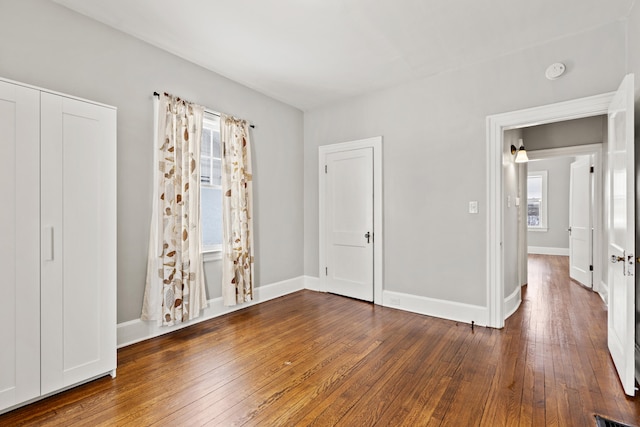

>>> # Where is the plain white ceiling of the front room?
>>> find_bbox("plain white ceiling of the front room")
[53,0,635,110]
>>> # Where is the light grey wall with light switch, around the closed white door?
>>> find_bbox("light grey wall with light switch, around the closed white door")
[304,22,626,306]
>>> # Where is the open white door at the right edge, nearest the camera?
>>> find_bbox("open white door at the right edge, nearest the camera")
[608,74,635,396]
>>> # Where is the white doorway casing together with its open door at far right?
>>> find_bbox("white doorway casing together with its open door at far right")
[487,74,640,396]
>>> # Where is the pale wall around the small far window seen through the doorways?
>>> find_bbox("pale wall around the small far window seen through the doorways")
[527,157,574,254]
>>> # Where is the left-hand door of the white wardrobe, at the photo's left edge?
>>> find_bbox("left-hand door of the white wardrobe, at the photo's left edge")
[0,82,40,411]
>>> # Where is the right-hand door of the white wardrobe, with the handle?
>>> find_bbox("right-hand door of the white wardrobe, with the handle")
[41,92,116,394]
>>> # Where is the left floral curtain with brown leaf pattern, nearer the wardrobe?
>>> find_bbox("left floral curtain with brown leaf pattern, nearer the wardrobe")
[141,93,207,326]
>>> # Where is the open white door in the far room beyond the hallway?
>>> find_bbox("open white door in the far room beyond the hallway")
[569,156,593,288]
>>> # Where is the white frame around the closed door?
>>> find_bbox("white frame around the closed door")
[318,136,384,305]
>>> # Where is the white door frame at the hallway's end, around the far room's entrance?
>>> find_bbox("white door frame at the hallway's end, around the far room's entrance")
[527,143,607,292]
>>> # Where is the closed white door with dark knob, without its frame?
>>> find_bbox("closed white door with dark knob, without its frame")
[320,147,374,301]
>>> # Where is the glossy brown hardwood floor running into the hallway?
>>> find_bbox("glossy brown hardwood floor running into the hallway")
[0,256,640,426]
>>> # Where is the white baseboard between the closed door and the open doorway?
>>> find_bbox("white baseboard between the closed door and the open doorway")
[382,291,489,326]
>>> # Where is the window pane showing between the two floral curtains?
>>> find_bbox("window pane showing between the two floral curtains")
[200,113,222,253]
